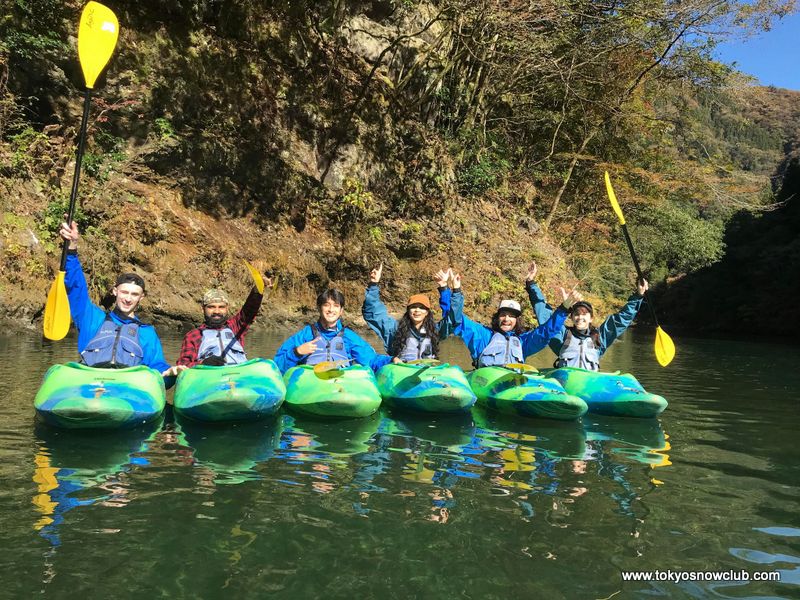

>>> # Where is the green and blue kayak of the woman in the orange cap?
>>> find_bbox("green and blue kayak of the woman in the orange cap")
[377,363,475,413]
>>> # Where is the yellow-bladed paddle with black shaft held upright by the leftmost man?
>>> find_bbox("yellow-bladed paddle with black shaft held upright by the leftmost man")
[43,2,119,340]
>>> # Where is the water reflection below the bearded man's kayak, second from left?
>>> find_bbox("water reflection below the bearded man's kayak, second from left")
[178,417,283,483]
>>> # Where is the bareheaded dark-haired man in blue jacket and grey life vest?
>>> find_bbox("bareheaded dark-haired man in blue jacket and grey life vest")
[275,289,391,373]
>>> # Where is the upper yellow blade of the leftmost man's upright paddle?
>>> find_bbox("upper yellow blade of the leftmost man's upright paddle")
[78,2,119,89]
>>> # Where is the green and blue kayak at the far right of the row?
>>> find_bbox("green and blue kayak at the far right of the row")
[543,367,667,418]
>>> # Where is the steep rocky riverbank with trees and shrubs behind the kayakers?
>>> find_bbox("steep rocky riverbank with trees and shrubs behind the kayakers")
[0,0,800,338]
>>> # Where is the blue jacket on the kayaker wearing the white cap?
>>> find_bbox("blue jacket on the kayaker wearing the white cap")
[450,290,568,361]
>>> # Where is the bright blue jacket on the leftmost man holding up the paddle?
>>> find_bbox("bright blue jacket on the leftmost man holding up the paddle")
[64,253,170,373]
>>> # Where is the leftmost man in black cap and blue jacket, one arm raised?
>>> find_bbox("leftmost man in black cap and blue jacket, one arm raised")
[59,221,186,377]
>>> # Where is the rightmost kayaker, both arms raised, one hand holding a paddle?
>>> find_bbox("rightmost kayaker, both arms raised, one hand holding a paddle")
[525,262,650,371]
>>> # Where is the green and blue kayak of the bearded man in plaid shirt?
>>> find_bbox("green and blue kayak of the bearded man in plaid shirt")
[174,358,286,421]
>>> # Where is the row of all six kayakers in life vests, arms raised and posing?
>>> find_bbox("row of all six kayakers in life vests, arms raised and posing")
[60,222,648,379]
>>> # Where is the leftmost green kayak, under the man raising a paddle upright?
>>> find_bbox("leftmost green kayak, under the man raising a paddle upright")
[33,363,166,429]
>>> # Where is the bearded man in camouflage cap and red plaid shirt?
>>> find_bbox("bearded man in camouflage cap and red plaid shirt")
[178,278,271,367]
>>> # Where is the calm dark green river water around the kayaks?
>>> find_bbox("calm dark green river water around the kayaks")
[0,332,800,600]
